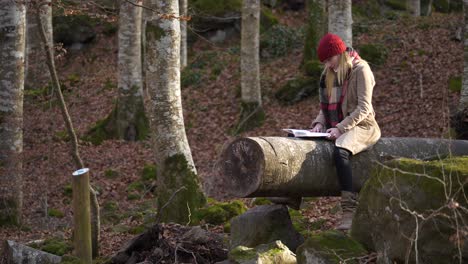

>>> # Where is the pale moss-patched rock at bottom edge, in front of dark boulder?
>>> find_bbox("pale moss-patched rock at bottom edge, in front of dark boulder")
[227,240,296,264]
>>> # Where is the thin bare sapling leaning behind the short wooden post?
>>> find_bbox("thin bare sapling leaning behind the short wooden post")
[36,3,101,257]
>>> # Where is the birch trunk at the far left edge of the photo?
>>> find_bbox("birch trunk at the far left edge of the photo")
[0,0,26,225]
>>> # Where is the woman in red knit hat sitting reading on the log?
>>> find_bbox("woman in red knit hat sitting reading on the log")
[310,33,381,230]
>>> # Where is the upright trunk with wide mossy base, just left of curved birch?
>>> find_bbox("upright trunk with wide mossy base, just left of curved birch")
[113,0,148,141]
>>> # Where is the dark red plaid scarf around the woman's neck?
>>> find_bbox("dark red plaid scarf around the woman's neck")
[319,47,360,128]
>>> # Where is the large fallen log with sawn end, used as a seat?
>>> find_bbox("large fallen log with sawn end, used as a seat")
[204,137,468,199]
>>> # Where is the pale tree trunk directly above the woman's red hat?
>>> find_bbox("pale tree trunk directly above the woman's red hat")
[328,0,353,47]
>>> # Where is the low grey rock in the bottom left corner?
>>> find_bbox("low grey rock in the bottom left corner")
[0,240,62,264]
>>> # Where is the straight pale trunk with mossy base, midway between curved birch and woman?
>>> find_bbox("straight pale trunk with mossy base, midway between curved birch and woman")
[235,0,264,134]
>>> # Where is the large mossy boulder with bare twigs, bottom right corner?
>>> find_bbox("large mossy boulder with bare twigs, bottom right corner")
[351,156,468,263]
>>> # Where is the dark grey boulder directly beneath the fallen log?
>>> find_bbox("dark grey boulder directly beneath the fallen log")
[230,205,304,251]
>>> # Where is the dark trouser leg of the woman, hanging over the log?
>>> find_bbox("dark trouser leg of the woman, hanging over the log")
[333,146,353,192]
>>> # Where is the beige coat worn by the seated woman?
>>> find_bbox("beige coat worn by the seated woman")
[311,60,381,155]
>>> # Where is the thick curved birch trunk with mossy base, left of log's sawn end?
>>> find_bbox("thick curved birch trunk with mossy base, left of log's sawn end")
[146,0,206,224]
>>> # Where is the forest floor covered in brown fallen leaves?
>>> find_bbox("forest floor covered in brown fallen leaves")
[0,3,463,262]
